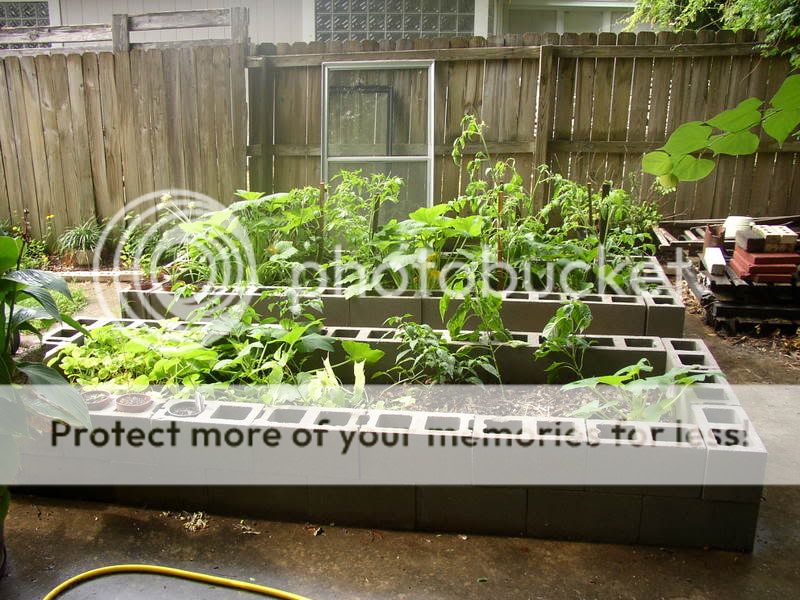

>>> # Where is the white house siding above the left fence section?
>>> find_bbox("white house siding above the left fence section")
[50,0,304,43]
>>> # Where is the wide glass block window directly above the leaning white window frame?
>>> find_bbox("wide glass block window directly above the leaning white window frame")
[314,0,475,42]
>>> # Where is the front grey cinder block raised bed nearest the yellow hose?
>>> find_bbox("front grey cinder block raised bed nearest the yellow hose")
[23,323,766,551]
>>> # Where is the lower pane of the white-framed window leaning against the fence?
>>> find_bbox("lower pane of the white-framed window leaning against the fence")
[328,161,428,224]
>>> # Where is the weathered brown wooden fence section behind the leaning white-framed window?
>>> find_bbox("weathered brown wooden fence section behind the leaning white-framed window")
[248,31,800,218]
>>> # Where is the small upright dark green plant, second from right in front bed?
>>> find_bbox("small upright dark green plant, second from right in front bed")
[534,300,592,382]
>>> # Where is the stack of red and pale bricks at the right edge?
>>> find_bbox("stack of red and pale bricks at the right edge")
[731,225,800,283]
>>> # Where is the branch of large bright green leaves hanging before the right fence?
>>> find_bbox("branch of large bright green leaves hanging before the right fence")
[642,75,800,190]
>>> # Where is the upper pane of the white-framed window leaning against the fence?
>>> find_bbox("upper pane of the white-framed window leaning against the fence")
[328,68,428,156]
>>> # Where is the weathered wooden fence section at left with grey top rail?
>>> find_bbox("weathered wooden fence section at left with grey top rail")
[0,9,247,235]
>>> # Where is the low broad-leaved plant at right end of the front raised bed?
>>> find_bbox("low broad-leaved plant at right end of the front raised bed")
[562,358,708,422]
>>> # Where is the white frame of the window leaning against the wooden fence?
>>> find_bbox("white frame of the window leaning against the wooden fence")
[320,60,435,207]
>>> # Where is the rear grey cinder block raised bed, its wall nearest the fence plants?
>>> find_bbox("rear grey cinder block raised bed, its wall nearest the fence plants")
[120,259,684,337]
